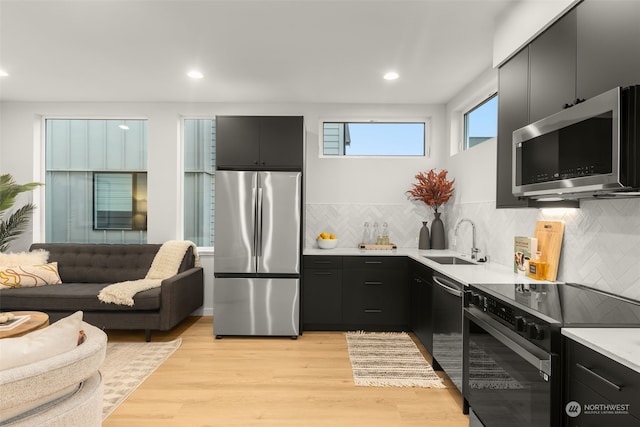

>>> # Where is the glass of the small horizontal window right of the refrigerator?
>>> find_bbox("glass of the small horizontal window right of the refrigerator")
[322,122,426,156]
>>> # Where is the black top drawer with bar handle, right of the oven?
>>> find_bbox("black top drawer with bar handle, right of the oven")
[567,340,640,418]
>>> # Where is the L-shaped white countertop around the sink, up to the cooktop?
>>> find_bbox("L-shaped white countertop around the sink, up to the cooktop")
[303,248,548,285]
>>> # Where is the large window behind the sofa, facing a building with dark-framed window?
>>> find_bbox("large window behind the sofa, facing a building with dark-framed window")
[44,119,147,243]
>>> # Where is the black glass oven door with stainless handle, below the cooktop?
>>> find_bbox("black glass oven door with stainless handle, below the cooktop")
[463,307,560,427]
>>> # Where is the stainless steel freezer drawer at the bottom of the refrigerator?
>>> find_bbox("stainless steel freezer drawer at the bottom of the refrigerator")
[213,278,300,337]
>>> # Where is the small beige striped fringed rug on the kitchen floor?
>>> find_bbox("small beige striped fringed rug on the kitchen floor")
[345,332,445,388]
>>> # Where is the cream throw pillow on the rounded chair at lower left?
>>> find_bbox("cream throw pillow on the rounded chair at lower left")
[0,311,82,371]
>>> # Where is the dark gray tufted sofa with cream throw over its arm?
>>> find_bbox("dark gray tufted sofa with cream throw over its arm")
[0,243,204,341]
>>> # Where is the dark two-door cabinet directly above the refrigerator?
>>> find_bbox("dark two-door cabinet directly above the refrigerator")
[216,116,304,170]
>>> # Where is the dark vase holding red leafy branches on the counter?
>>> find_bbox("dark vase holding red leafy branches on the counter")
[407,169,455,249]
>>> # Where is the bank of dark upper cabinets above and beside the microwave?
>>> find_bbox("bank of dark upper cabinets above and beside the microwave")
[496,0,640,208]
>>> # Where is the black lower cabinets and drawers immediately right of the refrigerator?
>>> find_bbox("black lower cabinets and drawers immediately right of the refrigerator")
[302,255,409,331]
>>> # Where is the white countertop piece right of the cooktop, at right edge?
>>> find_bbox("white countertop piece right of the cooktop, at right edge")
[562,328,640,373]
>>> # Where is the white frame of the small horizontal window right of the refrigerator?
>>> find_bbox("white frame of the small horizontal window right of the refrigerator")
[318,117,432,159]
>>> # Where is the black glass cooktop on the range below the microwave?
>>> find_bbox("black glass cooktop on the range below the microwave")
[471,283,640,327]
